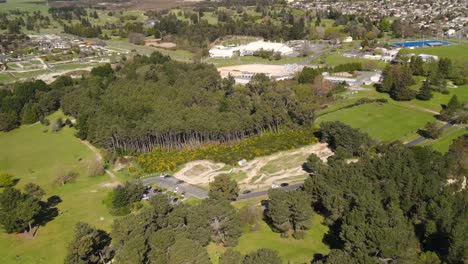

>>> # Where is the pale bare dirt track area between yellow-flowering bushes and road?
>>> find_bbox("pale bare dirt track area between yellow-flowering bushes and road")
[174,143,333,190]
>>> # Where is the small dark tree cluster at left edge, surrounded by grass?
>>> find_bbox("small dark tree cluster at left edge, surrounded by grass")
[0,182,61,236]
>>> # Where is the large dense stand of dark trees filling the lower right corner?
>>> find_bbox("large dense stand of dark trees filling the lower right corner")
[304,123,468,263]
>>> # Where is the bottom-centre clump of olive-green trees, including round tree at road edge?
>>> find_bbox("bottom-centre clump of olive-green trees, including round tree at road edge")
[65,175,286,264]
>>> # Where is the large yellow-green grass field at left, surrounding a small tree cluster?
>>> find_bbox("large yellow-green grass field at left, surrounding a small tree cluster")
[0,111,112,264]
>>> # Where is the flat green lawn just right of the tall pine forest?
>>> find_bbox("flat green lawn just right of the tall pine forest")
[317,103,435,141]
